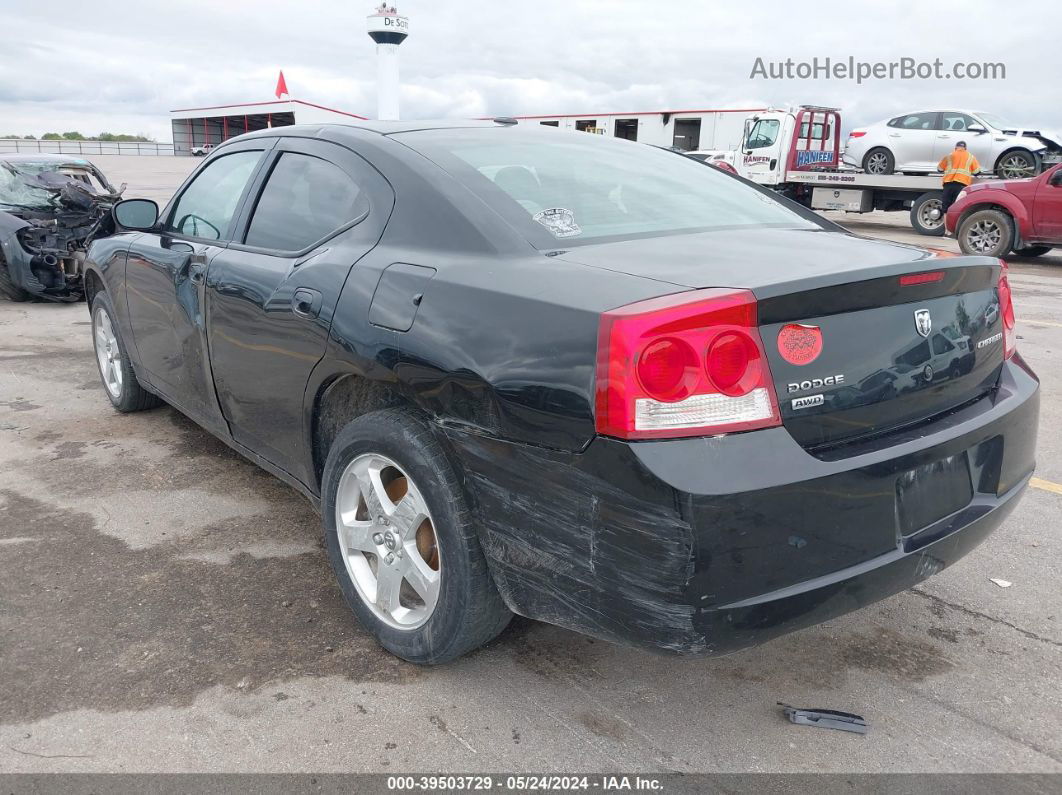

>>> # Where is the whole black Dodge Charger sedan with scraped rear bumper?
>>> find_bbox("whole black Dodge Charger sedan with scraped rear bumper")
[86,120,1039,662]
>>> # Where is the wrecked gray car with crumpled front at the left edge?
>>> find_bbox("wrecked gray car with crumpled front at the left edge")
[0,154,125,301]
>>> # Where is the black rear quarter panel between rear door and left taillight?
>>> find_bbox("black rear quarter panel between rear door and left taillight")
[315,249,681,451]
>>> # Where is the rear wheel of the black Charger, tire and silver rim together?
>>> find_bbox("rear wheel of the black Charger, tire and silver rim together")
[321,409,512,664]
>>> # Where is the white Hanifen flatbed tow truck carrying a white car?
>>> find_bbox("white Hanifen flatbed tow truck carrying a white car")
[695,105,993,236]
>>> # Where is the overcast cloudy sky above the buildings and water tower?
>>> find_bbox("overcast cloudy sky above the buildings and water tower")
[0,0,1062,140]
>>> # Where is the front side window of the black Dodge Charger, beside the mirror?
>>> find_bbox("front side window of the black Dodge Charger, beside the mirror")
[167,151,261,240]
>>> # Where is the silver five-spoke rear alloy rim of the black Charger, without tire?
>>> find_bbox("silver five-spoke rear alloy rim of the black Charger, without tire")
[336,453,442,629]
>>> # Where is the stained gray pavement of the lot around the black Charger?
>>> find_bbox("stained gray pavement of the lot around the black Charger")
[0,157,1062,773]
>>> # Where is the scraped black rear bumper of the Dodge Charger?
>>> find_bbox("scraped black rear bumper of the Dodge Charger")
[448,358,1039,654]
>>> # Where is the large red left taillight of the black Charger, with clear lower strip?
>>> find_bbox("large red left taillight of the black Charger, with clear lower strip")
[596,290,781,438]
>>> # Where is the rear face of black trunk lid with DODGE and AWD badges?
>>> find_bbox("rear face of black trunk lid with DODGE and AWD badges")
[759,258,1004,451]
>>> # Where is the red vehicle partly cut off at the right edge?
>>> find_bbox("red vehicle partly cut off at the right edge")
[945,165,1062,257]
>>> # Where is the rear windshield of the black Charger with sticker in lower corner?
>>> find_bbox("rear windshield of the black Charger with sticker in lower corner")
[396,128,820,247]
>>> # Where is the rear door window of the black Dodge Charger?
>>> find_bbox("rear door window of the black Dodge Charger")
[244,152,367,252]
